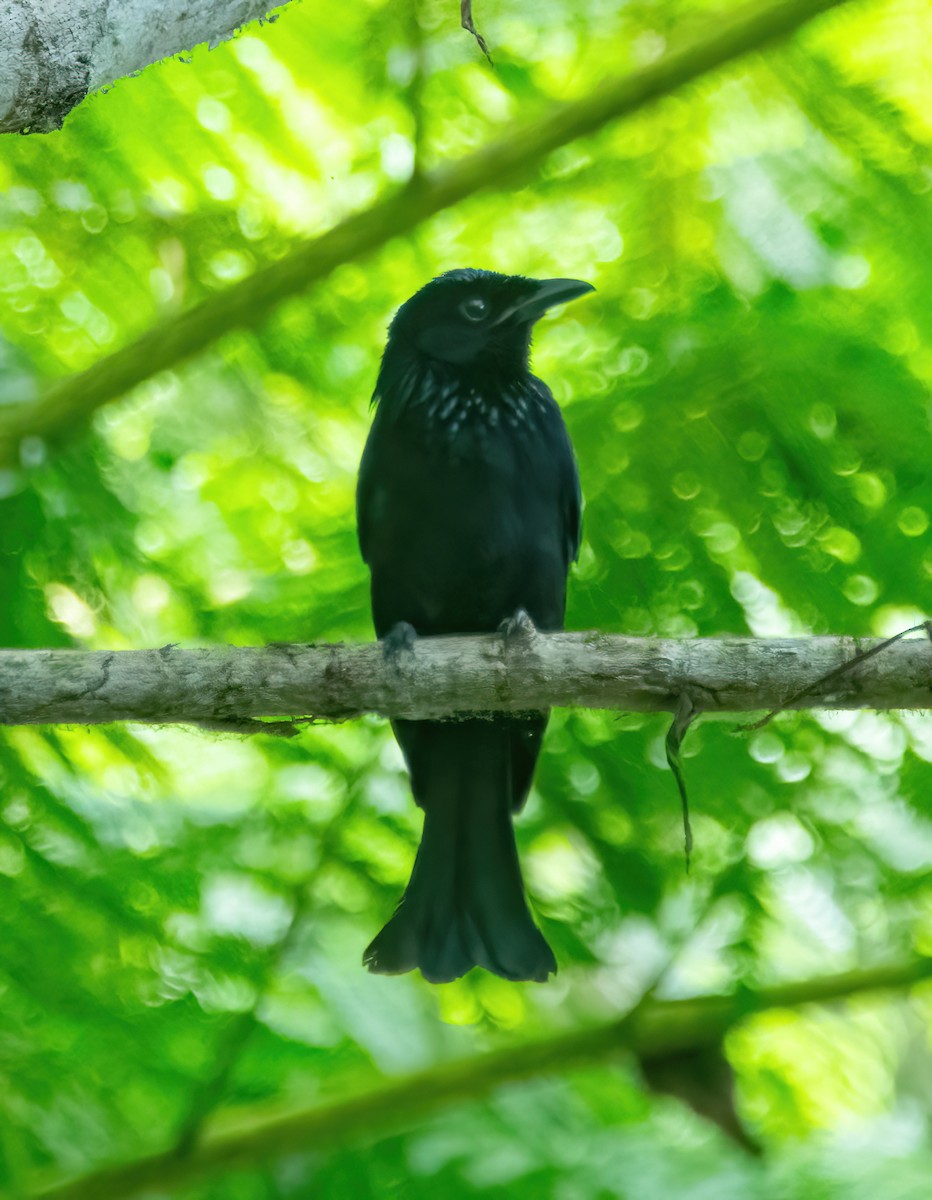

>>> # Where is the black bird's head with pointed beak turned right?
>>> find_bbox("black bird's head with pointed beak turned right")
[385,268,595,376]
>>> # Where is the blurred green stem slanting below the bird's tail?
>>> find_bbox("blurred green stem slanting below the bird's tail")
[32,959,932,1200]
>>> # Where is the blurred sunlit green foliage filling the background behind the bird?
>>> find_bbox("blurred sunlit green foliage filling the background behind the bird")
[0,0,932,1198]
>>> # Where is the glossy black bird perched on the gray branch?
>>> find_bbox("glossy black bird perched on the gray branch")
[356,269,594,983]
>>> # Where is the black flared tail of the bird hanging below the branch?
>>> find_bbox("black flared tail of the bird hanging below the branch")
[362,734,557,983]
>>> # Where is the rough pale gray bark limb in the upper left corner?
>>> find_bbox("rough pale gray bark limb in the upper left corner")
[0,0,287,133]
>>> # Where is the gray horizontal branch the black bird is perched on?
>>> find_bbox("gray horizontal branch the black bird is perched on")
[0,632,932,732]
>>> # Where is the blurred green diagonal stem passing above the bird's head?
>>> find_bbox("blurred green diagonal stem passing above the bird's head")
[0,0,849,466]
